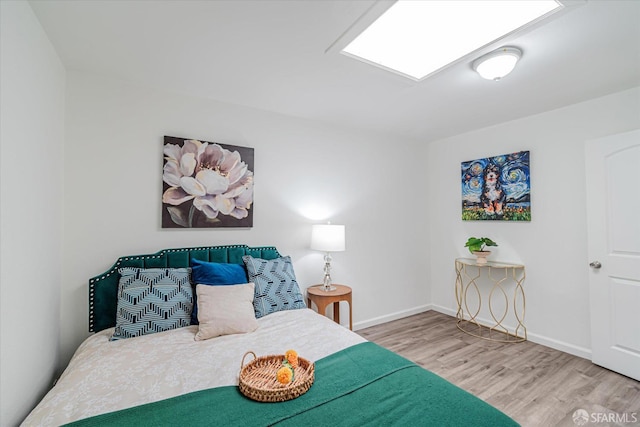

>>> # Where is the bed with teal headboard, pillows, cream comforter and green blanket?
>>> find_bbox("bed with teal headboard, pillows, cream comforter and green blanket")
[22,245,517,427]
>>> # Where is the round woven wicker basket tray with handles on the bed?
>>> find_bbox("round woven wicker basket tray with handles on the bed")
[238,351,315,402]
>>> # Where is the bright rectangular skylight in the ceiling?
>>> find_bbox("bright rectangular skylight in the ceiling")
[342,0,562,80]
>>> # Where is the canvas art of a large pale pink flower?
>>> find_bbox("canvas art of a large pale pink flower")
[162,136,254,228]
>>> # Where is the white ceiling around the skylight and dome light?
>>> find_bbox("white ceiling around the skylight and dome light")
[30,0,640,141]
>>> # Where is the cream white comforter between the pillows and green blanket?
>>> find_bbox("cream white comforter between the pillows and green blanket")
[22,309,365,426]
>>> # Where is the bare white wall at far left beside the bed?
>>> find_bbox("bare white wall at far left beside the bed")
[0,1,65,426]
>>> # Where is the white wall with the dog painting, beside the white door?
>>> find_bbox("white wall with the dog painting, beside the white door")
[424,88,640,357]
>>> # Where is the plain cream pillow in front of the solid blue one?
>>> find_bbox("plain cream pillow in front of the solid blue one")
[195,283,258,341]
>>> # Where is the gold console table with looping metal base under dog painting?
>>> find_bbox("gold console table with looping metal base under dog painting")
[455,258,527,342]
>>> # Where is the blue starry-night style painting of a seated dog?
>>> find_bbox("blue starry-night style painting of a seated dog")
[461,151,531,221]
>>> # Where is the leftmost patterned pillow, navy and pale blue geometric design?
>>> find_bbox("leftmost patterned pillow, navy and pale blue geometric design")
[111,267,193,341]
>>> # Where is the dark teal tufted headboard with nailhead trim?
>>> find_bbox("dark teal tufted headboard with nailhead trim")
[89,245,280,332]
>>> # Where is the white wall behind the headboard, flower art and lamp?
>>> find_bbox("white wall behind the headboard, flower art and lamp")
[61,72,428,366]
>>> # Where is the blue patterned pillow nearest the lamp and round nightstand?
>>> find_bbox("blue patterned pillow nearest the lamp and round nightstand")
[242,255,307,318]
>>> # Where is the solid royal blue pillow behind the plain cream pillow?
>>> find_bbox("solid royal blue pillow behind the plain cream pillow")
[191,258,247,325]
